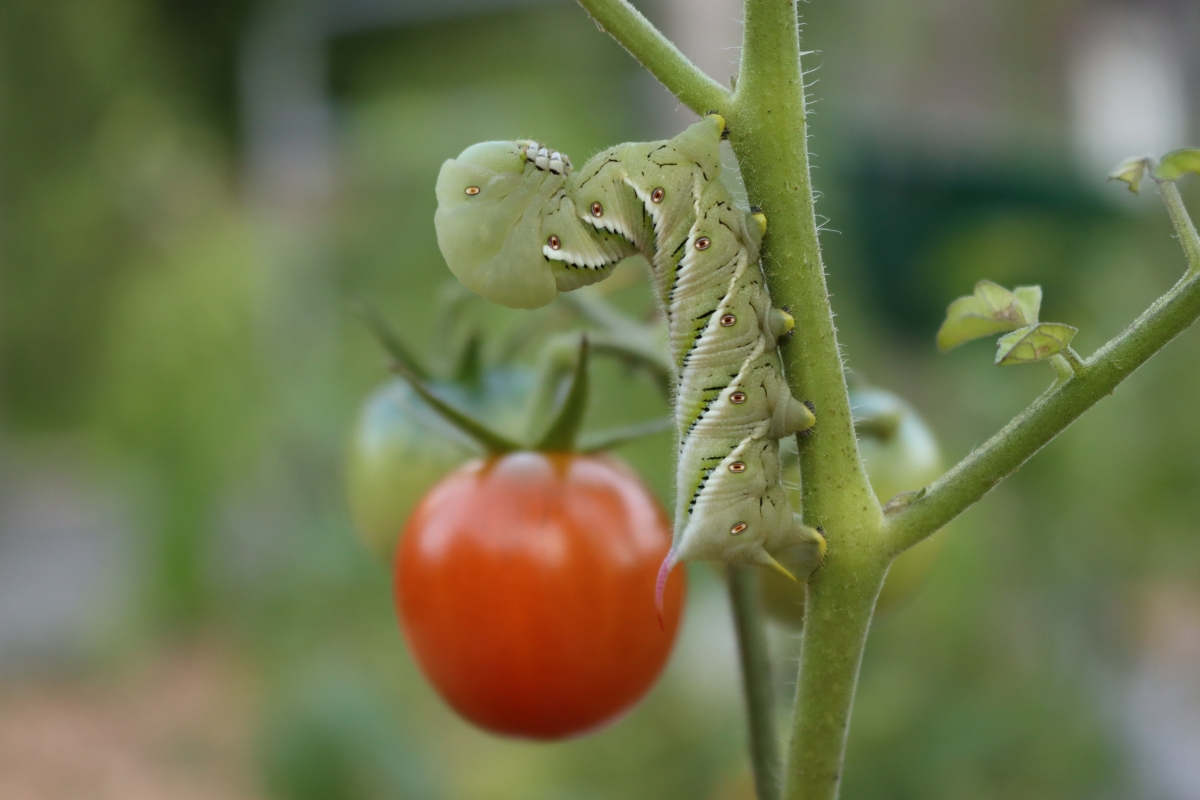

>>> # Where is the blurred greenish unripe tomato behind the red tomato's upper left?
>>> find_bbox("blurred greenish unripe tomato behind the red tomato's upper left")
[346,369,532,564]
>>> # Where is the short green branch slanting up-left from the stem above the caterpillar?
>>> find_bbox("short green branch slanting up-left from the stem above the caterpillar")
[578,0,730,115]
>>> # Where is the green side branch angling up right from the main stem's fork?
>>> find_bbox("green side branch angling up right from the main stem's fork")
[887,271,1200,553]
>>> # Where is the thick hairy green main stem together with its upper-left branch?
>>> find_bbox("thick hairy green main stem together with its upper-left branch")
[580,0,887,800]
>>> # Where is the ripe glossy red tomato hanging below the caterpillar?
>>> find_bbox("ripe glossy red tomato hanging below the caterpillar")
[396,452,685,739]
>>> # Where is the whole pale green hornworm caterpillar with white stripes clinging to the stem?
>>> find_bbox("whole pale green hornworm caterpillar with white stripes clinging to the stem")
[434,114,824,606]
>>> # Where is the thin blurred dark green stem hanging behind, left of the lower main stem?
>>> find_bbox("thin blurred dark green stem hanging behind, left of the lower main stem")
[728,566,782,800]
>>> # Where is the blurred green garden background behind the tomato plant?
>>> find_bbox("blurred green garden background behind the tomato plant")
[0,0,1200,800]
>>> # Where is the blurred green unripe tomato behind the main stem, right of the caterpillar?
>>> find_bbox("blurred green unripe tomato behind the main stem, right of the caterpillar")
[761,389,942,625]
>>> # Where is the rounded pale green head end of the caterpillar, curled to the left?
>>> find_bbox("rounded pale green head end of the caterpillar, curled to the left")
[433,140,632,308]
